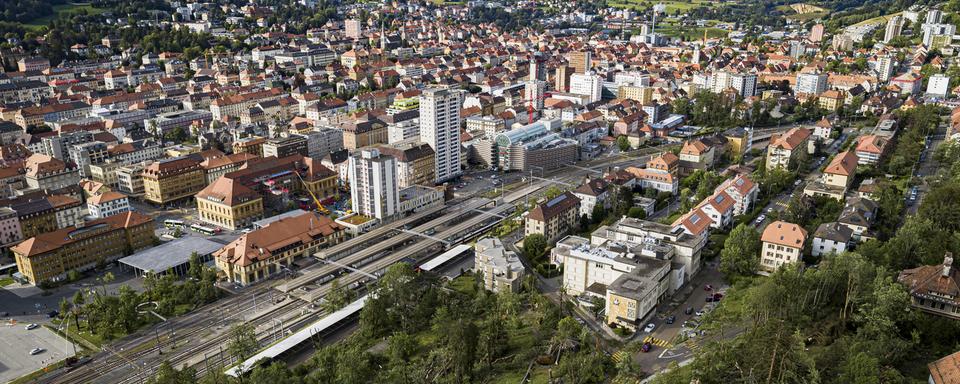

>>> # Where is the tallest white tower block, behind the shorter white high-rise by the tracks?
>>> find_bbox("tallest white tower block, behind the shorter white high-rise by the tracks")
[420,88,463,183]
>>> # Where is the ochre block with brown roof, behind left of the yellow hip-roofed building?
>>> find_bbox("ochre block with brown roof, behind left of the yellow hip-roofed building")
[143,155,206,205]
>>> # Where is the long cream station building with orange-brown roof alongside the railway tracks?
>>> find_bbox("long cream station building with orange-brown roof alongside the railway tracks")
[213,212,345,285]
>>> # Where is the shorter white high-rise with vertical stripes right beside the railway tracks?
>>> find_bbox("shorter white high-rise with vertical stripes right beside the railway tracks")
[348,149,400,220]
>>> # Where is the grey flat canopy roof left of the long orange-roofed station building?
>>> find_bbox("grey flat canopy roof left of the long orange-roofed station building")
[119,236,223,272]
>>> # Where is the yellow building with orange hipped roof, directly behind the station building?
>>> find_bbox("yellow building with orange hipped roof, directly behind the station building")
[196,176,263,230]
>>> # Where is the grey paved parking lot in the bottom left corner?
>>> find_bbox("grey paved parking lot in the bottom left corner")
[0,319,73,383]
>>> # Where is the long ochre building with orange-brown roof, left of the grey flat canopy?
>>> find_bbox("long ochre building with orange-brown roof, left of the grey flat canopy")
[10,212,154,285]
